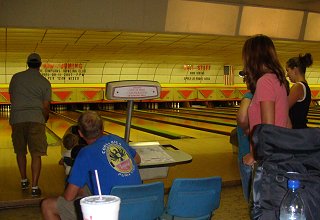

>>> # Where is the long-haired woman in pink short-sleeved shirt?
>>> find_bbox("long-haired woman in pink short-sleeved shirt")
[242,35,290,165]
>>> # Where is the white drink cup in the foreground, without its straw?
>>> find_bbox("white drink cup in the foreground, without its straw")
[80,195,121,220]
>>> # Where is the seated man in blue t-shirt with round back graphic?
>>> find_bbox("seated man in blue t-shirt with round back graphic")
[41,111,142,219]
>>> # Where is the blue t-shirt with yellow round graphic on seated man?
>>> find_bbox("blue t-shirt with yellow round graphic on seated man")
[68,135,142,195]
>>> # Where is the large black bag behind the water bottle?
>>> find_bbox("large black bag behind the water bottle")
[251,124,320,220]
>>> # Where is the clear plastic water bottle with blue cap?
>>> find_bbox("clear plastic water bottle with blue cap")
[280,179,306,220]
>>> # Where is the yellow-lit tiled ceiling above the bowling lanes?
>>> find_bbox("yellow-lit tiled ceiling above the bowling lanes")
[0,0,320,66]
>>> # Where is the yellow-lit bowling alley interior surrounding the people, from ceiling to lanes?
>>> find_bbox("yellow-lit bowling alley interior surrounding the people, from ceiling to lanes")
[0,0,320,220]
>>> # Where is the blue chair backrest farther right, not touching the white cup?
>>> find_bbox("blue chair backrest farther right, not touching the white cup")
[165,177,222,219]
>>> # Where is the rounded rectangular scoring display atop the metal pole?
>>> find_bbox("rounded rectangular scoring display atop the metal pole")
[106,80,161,100]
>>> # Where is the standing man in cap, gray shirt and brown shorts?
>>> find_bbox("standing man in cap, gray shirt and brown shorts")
[9,53,51,196]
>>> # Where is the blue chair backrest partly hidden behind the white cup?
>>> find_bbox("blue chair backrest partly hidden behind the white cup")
[110,182,164,220]
